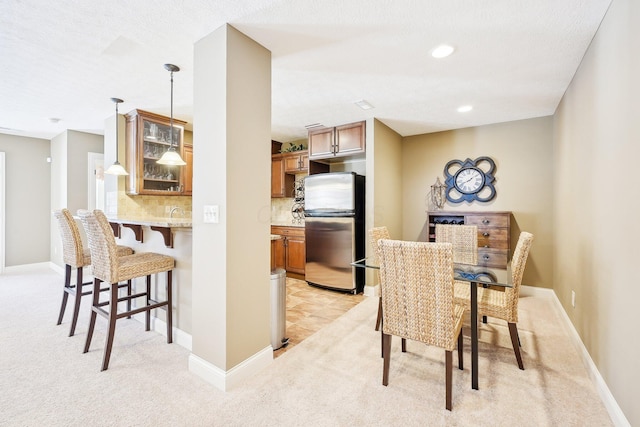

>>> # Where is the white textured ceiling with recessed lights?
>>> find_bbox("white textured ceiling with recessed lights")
[0,0,611,142]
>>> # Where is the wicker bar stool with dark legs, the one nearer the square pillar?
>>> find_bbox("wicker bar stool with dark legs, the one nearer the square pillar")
[78,210,175,371]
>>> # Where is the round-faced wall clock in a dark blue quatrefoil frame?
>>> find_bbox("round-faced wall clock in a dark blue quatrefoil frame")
[444,156,496,203]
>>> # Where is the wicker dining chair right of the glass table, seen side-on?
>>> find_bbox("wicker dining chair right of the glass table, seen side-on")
[454,231,533,370]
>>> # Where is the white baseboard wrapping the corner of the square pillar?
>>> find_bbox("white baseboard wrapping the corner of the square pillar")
[189,345,273,392]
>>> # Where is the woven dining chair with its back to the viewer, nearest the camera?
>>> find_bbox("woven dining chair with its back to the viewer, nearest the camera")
[378,239,464,410]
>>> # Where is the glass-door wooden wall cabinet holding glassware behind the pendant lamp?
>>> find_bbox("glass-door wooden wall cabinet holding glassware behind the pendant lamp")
[126,110,187,196]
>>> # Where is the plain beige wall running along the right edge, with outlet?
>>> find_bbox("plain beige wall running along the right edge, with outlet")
[554,0,640,425]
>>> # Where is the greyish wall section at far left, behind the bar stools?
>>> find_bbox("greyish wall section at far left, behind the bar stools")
[0,133,51,267]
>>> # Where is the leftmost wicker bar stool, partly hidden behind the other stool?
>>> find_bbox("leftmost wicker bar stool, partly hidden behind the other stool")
[53,208,133,337]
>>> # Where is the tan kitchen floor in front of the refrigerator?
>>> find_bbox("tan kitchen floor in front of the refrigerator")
[273,277,364,357]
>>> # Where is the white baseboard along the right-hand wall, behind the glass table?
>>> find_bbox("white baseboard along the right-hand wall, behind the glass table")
[520,286,631,427]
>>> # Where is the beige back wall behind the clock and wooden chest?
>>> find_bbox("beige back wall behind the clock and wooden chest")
[402,117,554,288]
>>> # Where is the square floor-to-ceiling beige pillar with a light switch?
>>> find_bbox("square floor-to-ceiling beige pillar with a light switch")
[192,25,271,372]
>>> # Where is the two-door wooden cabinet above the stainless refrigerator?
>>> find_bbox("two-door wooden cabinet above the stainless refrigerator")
[309,121,366,160]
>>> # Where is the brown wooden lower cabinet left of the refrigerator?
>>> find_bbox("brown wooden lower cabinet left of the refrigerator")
[271,225,306,274]
